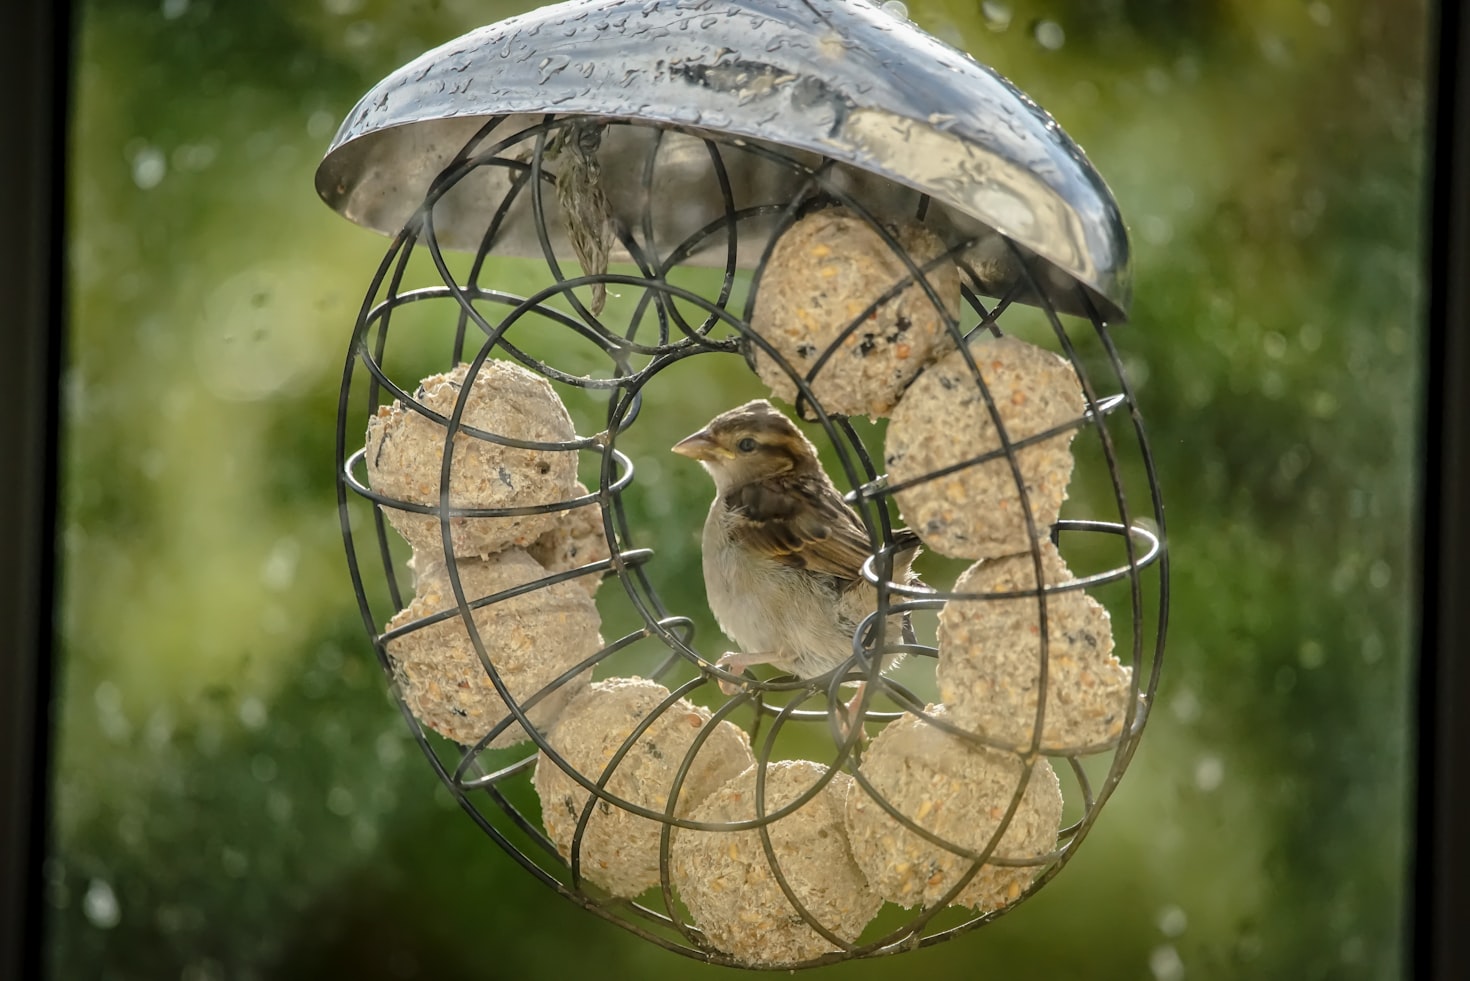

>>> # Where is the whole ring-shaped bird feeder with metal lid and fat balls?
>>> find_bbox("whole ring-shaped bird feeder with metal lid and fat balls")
[318,0,1169,969]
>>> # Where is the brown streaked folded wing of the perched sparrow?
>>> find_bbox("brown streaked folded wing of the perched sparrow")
[725,474,870,579]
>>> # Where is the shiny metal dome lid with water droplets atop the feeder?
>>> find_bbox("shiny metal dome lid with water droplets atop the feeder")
[316,0,1130,321]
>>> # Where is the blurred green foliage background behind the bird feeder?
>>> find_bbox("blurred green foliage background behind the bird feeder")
[47,0,1430,981]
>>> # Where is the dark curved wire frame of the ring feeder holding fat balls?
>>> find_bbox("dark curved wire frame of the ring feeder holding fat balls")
[337,115,1169,969]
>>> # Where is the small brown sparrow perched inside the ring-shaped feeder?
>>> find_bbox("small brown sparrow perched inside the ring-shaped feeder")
[673,399,919,705]
